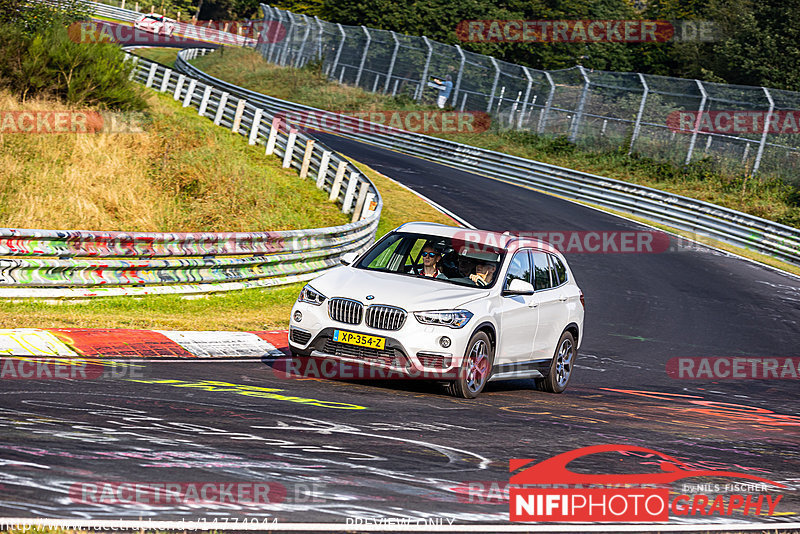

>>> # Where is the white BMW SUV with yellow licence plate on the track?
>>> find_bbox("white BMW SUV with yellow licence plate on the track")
[289,222,584,398]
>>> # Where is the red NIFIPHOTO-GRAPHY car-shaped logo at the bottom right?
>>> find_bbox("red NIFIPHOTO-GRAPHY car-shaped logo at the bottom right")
[509,444,786,523]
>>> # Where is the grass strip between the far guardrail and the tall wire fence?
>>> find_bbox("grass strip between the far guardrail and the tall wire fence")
[193,48,800,227]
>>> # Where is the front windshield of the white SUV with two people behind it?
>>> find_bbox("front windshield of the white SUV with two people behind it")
[355,232,504,287]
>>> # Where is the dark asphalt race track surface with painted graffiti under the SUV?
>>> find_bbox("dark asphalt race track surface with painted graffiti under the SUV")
[0,52,800,529]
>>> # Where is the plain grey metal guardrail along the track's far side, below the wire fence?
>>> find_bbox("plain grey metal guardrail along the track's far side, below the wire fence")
[175,49,800,265]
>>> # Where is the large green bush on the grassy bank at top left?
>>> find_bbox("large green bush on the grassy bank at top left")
[0,22,146,111]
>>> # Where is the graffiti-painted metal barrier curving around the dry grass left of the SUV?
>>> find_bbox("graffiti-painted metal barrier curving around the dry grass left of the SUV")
[0,50,383,298]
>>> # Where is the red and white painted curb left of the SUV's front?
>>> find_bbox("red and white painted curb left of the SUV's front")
[0,328,288,358]
